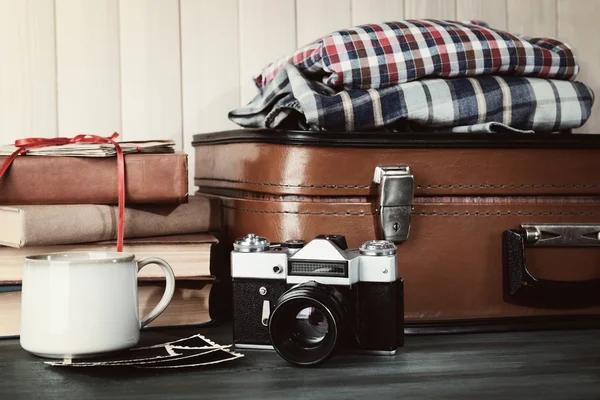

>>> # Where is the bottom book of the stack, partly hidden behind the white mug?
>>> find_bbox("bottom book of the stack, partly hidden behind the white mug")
[0,280,213,338]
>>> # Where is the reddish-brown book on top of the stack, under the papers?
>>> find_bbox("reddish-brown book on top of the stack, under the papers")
[0,153,188,204]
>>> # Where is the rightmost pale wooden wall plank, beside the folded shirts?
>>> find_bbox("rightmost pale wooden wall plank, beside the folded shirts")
[558,0,600,134]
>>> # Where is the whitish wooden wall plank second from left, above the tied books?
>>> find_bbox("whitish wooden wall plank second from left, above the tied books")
[55,0,121,136]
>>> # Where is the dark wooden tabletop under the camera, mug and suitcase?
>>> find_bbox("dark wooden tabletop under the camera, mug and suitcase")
[0,326,600,400]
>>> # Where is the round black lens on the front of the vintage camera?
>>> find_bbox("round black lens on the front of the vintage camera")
[269,281,344,366]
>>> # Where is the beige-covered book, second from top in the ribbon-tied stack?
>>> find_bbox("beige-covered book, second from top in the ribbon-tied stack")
[0,196,221,247]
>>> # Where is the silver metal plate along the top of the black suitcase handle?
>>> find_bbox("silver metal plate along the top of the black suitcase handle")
[521,224,600,247]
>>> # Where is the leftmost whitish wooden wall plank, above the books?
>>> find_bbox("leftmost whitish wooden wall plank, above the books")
[0,0,57,144]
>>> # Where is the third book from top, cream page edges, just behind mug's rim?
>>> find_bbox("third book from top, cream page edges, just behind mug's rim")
[0,233,217,285]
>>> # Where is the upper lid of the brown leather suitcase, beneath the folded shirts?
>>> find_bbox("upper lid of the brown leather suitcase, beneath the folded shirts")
[193,129,600,201]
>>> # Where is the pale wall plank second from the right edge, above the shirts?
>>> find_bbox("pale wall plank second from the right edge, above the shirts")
[507,0,556,37]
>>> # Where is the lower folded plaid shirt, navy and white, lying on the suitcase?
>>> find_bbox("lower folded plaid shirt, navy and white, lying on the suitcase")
[229,64,594,132]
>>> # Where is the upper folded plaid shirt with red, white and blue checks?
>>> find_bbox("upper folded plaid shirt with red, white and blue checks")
[255,19,579,89]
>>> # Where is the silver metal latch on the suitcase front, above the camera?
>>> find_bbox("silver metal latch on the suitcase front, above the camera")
[373,165,415,243]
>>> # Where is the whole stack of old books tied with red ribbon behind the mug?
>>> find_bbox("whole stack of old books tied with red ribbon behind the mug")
[0,143,220,337]
